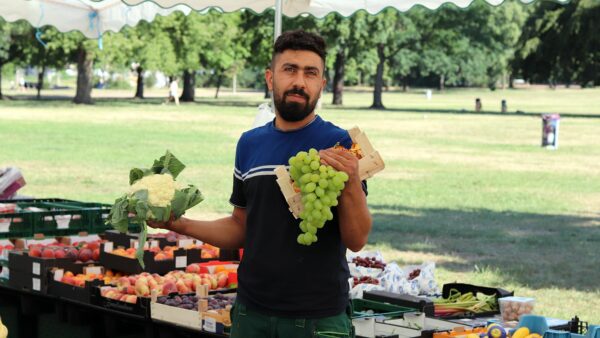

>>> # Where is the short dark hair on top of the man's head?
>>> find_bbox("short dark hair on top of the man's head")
[271,29,327,66]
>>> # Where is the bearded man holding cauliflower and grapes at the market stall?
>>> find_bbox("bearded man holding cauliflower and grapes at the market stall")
[153,31,371,338]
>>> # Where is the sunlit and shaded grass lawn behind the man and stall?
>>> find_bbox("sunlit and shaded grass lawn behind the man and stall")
[0,88,600,324]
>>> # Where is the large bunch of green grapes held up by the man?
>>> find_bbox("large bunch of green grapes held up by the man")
[289,148,348,245]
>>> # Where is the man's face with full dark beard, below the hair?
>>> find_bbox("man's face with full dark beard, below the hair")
[265,49,325,122]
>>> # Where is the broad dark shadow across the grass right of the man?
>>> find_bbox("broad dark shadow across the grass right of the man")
[369,205,600,290]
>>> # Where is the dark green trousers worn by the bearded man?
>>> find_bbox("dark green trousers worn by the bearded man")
[231,302,354,338]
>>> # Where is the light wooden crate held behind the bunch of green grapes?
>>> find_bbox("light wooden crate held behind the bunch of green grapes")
[275,127,385,218]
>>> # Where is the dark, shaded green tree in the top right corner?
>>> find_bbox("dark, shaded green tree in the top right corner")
[514,0,600,86]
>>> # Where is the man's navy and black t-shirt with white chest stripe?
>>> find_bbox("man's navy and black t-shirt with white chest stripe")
[230,116,366,318]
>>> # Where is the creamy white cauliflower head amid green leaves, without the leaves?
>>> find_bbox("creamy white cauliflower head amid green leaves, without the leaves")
[129,174,177,207]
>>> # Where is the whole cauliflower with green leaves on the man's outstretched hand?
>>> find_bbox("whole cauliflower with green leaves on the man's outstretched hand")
[106,151,204,268]
